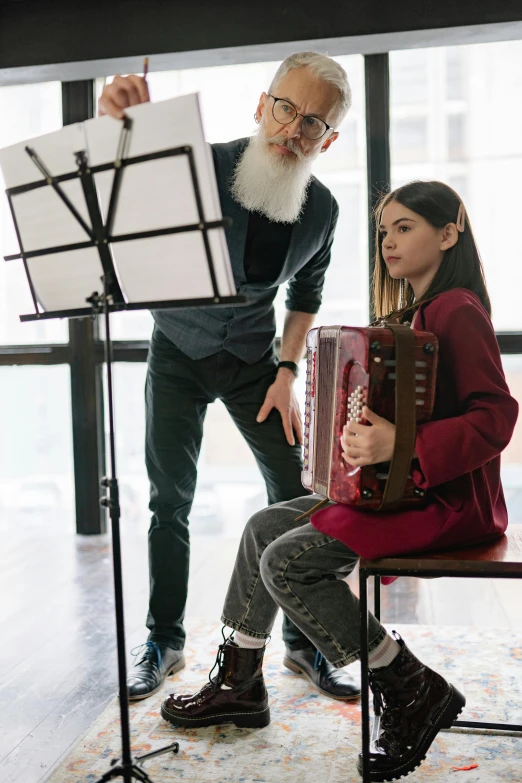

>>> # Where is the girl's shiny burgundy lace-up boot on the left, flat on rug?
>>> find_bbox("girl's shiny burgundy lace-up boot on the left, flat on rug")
[161,639,270,729]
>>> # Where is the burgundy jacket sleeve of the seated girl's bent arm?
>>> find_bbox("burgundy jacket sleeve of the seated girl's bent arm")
[412,300,518,489]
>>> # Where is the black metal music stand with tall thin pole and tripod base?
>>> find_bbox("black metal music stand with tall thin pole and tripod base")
[4,102,246,783]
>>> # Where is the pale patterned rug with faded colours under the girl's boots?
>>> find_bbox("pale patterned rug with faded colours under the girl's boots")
[47,624,522,783]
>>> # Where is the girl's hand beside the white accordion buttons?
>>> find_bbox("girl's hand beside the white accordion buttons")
[341,405,395,468]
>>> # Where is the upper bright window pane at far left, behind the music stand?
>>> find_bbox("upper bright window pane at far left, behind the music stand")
[0,82,68,345]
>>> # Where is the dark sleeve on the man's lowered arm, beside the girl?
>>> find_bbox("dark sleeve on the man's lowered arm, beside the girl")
[286,196,339,313]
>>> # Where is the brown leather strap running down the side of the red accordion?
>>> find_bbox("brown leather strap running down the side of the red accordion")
[379,324,417,510]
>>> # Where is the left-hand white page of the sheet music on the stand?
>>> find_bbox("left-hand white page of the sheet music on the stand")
[0,123,103,311]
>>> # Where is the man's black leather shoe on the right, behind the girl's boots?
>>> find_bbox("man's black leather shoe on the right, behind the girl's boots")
[283,647,361,701]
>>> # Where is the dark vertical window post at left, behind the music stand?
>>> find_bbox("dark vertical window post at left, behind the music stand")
[62,80,106,534]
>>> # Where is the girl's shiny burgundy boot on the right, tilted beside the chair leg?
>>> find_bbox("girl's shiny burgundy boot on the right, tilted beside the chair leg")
[357,634,466,782]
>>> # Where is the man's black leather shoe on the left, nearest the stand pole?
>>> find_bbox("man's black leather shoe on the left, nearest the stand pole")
[127,642,185,701]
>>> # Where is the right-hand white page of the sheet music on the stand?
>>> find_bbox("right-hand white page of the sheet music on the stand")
[84,94,236,302]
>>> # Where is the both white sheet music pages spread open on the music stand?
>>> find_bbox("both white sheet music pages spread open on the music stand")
[0,94,236,318]
